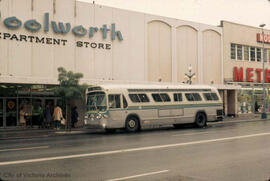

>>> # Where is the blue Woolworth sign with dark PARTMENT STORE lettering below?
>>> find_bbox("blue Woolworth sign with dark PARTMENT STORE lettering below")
[0,13,123,50]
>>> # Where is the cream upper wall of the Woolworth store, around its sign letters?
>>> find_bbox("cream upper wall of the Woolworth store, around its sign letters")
[0,0,222,84]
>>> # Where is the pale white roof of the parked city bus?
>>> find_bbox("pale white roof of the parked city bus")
[89,83,216,90]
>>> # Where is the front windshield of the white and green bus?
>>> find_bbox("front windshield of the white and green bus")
[87,92,107,111]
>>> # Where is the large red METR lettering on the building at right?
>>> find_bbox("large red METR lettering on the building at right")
[233,67,270,83]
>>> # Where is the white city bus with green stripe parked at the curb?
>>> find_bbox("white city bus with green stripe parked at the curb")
[84,84,223,132]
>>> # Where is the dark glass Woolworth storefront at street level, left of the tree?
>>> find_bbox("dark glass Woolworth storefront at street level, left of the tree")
[0,84,59,127]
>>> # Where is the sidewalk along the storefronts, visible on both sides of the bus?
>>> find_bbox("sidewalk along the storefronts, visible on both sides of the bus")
[0,114,270,141]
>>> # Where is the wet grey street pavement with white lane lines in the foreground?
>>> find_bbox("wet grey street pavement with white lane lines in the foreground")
[0,120,270,181]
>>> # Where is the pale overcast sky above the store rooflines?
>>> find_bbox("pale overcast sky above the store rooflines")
[78,0,270,29]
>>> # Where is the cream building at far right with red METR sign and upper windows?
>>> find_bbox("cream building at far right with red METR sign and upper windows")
[221,21,270,115]
